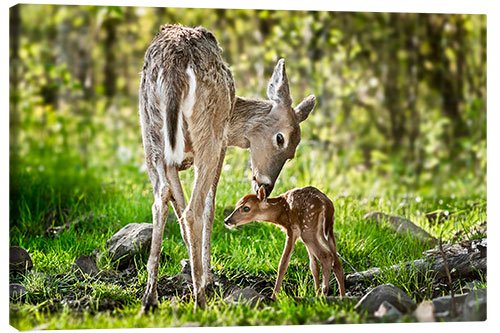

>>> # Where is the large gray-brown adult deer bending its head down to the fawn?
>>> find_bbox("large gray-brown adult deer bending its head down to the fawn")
[139,25,315,312]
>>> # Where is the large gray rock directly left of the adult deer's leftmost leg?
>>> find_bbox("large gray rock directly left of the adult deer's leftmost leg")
[97,223,153,268]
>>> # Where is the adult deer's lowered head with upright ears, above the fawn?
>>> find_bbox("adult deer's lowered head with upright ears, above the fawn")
[248,59,316,197]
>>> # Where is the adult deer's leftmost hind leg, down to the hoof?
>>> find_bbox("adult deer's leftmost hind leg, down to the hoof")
[141,161,171,312]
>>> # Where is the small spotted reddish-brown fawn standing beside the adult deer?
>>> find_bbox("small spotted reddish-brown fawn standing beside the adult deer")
[224,186,345,299]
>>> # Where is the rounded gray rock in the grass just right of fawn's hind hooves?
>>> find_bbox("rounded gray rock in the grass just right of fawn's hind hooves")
[354,284,416,315]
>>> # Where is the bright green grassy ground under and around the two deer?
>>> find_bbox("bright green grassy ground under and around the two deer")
[10,144,486,330]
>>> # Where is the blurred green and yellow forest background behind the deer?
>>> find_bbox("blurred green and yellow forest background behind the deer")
[10,4,486,228]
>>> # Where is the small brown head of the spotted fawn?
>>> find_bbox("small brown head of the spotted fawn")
[224,186,269,229]
